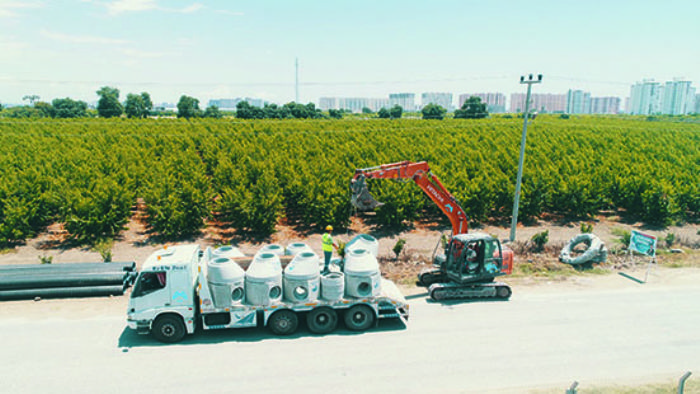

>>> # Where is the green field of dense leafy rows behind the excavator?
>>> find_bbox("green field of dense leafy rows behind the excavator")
[0,115,700,245]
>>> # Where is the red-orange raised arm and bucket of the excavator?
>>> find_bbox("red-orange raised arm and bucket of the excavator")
[350,161,468,236]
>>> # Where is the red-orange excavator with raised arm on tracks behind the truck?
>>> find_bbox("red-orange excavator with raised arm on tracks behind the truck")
[350,161,513,301]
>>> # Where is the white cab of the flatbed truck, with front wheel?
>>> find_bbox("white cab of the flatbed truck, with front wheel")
[127,245,200,342]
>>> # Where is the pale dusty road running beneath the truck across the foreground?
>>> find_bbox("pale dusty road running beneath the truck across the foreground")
[0,277,700,393]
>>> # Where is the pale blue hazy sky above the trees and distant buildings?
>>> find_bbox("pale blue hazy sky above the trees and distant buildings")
[0,0,700,105]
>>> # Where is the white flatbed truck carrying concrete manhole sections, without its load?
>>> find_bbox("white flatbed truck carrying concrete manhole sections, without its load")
[127,245,409,343]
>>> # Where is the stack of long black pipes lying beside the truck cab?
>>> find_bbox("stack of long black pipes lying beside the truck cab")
[0,262,137,301]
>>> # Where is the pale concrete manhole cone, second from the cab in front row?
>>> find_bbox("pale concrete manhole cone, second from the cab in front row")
[245,252,282,305]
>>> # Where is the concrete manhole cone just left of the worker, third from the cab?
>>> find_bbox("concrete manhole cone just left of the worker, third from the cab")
[283,252,321,302]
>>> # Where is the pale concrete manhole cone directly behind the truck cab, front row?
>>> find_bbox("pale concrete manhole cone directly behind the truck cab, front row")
[207,257,245,308]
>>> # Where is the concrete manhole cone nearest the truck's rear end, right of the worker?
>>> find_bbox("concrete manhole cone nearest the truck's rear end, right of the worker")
[344,249,382,298]
